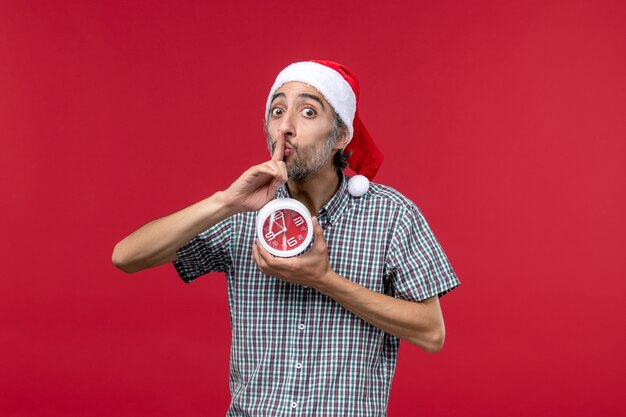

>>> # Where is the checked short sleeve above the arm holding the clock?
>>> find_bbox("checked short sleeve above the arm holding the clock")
[387,205,460,301]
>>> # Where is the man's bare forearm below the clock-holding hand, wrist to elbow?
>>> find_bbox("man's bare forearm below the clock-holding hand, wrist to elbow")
[317,271,445,352]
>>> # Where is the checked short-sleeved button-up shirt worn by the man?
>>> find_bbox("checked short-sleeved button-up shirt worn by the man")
[174,174,459,417]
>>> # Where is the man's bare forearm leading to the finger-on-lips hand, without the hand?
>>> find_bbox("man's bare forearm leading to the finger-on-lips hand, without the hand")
[113,192,234,273]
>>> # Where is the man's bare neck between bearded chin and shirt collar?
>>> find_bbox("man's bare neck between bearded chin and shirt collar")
[287,161,341,216]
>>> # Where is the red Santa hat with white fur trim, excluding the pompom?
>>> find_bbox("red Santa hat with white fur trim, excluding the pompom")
[265,61,384,180]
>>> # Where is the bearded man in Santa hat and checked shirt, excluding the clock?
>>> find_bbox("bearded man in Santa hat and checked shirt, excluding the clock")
[113,61,459,416]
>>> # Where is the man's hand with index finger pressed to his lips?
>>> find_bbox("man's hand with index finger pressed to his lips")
[224,133,287,212]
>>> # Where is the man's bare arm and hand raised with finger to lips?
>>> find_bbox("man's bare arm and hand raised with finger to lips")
[112,135,287,273]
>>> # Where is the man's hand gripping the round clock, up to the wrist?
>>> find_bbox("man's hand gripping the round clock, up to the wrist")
[253,217,333,289]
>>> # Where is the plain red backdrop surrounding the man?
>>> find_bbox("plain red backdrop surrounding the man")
[0,0,626,416]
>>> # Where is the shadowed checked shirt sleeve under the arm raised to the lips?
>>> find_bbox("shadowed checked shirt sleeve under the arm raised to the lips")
[173,218,231,283]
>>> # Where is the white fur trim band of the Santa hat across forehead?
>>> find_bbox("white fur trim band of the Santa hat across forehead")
[265,62,356,142]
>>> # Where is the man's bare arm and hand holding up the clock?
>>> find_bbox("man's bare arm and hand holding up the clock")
[253,219,445,353]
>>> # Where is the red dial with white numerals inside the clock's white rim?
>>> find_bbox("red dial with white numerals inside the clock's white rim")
[263,209,308,251]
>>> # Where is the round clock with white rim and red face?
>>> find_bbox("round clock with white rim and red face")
[256,198,313,258]
